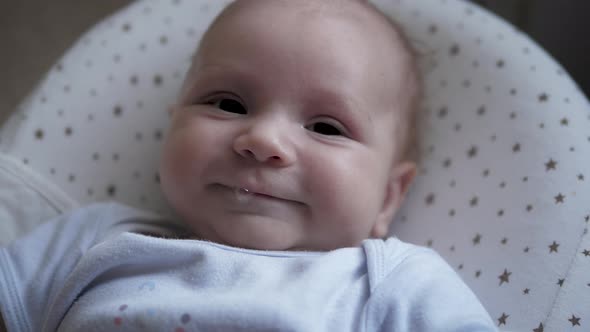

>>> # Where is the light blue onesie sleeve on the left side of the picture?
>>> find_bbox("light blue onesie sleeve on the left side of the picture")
[0,203,171,331]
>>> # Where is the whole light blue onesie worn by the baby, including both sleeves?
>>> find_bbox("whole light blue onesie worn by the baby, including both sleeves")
[0,204,496,332]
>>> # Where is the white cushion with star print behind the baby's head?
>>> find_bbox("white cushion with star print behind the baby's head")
[0,0,590,332]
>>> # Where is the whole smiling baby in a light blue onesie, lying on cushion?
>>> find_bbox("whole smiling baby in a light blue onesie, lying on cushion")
[0,0,496,331]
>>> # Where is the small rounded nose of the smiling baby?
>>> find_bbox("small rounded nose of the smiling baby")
[233,121,295,167]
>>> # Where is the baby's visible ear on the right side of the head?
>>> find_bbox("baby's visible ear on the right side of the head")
[371,161,416,238]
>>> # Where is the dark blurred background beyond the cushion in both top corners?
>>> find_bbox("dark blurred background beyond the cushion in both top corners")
[0,0,590,122]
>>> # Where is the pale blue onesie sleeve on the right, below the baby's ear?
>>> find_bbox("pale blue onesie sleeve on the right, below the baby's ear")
[366,241,498,332]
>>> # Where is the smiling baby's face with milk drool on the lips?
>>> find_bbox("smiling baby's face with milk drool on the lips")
[160,0,414,250]
